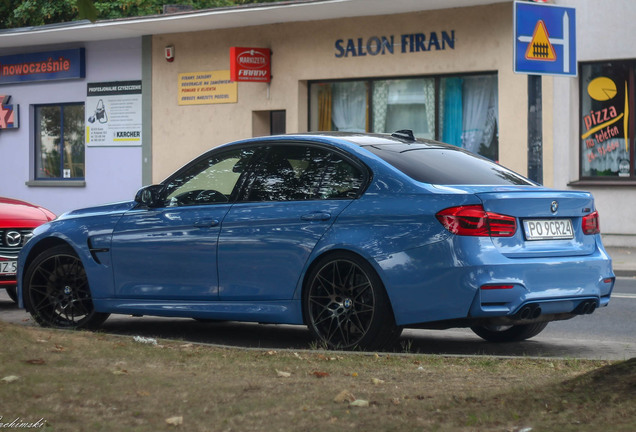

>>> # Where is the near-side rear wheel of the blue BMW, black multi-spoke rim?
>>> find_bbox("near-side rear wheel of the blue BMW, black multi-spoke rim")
[303,252,402,350]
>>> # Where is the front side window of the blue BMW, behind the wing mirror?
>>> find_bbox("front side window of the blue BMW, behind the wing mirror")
[164,147,256,207]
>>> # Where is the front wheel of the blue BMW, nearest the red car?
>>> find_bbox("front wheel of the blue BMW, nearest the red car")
[22,245,109,330]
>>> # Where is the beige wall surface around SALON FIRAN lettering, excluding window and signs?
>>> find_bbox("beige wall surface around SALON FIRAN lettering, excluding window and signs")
[152,3,540,182]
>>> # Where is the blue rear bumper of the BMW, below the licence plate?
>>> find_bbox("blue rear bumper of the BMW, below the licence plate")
[378,237,615,325]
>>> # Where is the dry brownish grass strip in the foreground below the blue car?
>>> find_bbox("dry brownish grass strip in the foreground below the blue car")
[0,322,636,432]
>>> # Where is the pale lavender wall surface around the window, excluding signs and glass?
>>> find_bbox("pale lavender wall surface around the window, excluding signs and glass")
[0,38,141,214]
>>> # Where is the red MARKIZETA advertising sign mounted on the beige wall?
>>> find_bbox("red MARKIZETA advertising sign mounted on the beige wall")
[230,47,272,82]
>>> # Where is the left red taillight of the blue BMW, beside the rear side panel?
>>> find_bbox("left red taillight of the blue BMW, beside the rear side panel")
[435,205,517,237]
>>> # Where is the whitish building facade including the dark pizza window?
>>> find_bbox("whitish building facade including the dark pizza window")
[548,0,636,247]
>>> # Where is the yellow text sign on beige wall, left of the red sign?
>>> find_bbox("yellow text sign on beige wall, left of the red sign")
[178,70,238,105]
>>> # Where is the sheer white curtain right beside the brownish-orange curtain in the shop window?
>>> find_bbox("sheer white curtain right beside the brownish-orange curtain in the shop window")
[332,82,367,132]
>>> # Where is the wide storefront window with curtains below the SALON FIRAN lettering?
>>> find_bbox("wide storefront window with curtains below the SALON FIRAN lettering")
[310,74,498,160]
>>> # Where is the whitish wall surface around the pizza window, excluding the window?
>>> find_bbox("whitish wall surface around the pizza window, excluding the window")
[553,0,636,247]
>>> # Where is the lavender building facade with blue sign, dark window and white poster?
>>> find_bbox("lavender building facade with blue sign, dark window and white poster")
[0,38,142,214]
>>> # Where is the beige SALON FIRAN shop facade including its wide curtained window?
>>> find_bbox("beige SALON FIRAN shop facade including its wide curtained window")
[152,2,540,183]
